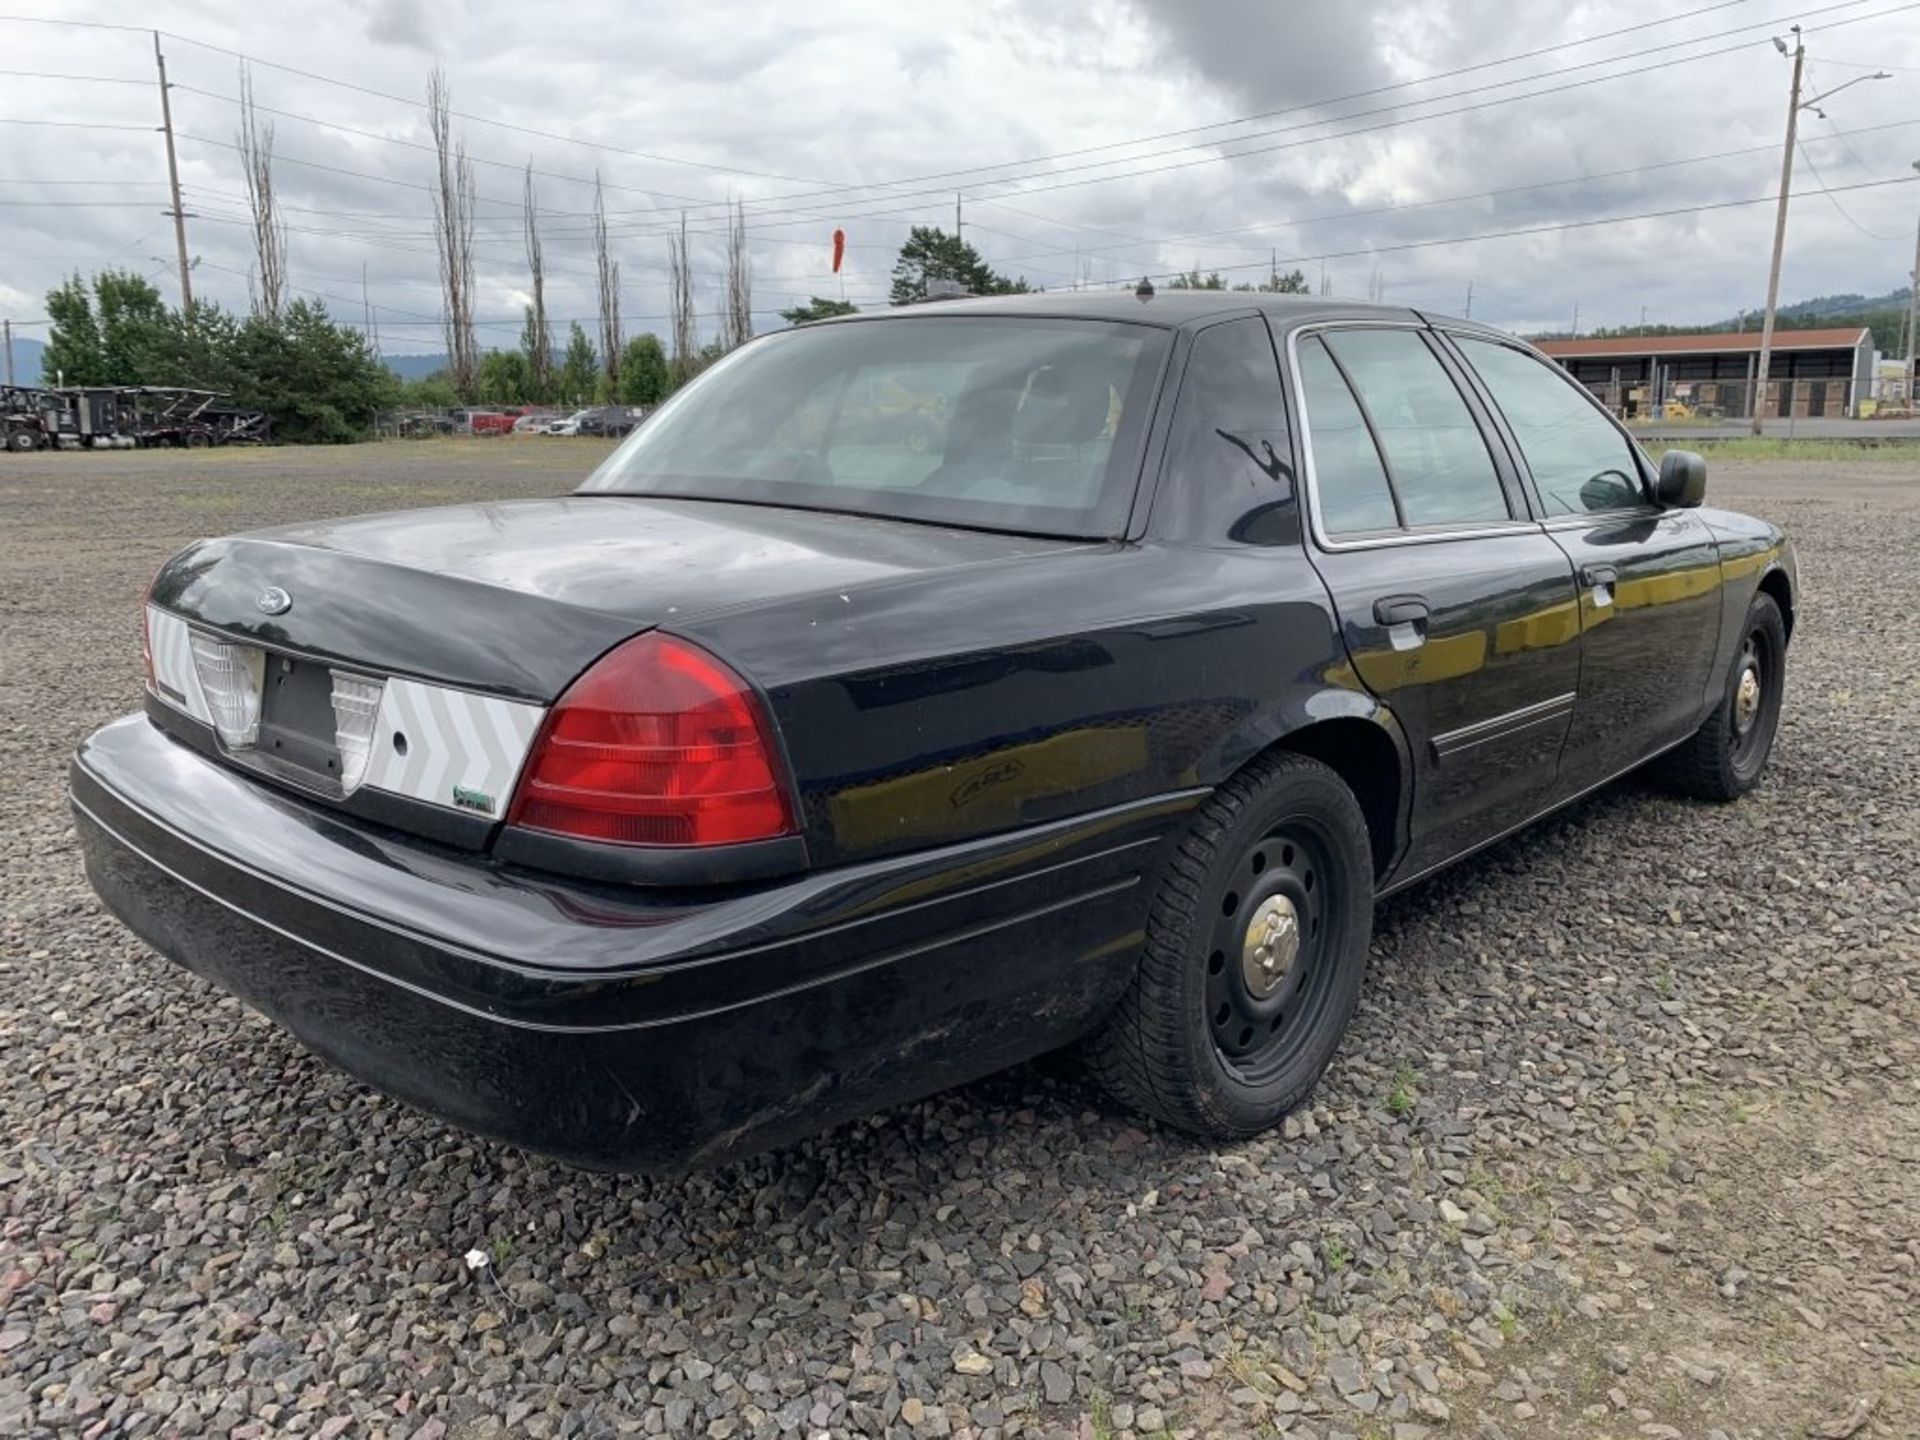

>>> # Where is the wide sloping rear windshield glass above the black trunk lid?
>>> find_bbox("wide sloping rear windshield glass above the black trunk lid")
[582,315,1169,536]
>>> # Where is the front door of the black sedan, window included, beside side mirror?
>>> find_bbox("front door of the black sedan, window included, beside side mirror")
[1450,334,1720,793]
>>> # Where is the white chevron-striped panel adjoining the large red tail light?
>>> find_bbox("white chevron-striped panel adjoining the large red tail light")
[361,678,545,820]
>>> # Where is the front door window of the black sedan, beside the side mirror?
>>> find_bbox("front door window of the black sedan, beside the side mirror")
[1455,336,1647,515]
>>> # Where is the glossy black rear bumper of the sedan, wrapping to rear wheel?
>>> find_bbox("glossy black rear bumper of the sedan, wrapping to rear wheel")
[69,716,1198,1169]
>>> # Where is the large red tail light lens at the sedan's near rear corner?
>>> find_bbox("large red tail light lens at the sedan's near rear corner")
[507,632,793,845]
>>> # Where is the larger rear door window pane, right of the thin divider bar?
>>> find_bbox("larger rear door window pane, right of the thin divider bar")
[1325,328,1511,528]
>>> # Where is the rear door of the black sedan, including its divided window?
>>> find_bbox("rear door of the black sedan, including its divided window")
[1286,323,1580,876]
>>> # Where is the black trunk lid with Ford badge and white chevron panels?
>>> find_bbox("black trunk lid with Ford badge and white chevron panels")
[148,495,1068,843]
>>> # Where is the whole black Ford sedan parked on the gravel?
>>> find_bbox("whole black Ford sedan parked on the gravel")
[71,292,1795,1169]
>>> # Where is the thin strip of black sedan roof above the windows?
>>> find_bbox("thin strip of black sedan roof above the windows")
[814,286,1500,334]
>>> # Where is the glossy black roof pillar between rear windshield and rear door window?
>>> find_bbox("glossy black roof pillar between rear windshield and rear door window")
[1156,317,1300,545]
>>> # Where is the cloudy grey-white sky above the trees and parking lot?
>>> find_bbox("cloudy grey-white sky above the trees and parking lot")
[0,0,1920,353]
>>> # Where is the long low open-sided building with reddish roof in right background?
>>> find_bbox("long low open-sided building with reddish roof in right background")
[1538,326,1874,420]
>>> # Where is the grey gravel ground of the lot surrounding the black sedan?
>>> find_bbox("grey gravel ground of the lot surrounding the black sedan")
[0,442,1920,1440]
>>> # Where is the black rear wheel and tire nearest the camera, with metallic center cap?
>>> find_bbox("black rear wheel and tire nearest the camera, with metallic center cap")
[1089,755,1373,1139]
